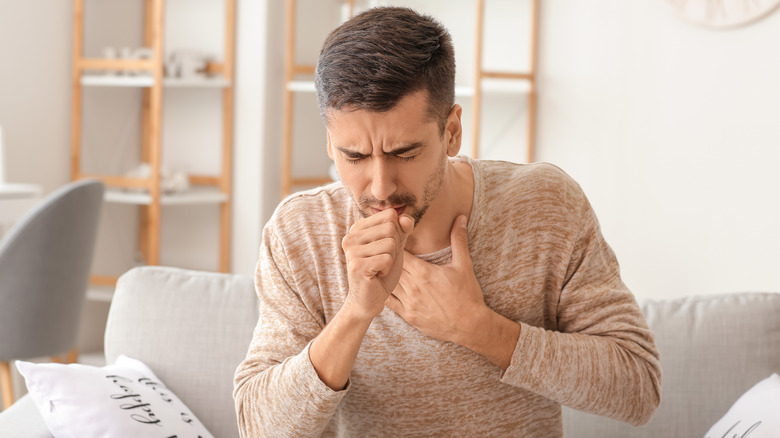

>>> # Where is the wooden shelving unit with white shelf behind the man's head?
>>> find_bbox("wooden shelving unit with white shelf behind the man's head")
[281,0,540,197]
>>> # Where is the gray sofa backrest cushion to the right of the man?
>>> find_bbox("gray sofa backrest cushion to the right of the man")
[563,293,780,438]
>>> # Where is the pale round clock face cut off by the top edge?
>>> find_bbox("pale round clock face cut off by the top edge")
[666,0,780,27]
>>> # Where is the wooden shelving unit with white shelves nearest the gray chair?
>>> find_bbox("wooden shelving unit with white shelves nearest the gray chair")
[71,0,236,286]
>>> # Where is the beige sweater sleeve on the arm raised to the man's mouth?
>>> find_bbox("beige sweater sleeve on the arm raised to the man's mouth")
[233,225,349,437]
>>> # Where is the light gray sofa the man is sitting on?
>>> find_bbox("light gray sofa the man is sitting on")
[0,267,780,438]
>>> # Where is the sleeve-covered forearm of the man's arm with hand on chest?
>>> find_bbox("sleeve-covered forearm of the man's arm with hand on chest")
[501,325,661,425]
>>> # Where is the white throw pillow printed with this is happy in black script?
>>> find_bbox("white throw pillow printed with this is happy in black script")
[16,356,213,438]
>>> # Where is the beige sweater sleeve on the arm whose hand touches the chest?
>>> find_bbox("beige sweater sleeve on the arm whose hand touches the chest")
[502,194,661,425]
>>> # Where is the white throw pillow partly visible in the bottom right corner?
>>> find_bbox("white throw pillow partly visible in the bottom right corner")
[705,374,780,438]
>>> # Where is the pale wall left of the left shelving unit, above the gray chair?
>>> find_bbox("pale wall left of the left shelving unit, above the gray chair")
[0,0,72,192]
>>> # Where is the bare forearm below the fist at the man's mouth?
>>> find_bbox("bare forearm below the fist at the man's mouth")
[309,305,372,391]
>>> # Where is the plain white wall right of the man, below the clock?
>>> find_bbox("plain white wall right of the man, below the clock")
[537,0,780,297]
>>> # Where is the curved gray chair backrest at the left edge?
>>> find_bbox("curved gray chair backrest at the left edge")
[0,180,103,361]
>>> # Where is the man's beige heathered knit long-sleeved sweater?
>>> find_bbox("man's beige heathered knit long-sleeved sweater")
[234,158,661,437]
